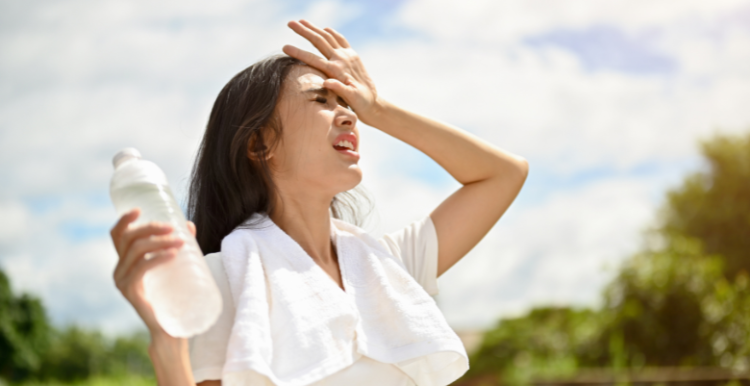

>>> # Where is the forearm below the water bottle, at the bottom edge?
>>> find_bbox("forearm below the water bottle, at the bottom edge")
[148,333,195,386]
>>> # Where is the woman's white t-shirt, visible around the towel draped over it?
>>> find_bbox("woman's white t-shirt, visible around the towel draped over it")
[189,216,438,386]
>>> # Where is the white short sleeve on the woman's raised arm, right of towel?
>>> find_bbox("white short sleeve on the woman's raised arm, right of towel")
[378,216,438,296]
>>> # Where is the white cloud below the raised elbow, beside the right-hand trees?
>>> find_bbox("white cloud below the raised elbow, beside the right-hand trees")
[439,178,655,328]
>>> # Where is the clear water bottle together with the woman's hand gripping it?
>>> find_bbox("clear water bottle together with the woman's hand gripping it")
[110,148,222,338]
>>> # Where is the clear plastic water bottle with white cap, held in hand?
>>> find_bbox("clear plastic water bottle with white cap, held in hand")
[110,148,222,338]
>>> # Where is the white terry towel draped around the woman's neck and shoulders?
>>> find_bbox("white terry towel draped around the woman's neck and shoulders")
[221,214,469,386]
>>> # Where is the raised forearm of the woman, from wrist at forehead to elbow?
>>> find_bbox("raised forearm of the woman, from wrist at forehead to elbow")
[366,101,527,185]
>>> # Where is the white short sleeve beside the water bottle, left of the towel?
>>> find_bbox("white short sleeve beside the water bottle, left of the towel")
[188,253,235,383]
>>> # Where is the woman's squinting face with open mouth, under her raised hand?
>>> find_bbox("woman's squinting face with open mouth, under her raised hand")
[268,66,362,198]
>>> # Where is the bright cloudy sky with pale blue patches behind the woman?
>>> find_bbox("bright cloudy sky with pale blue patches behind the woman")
[0,0,750,334]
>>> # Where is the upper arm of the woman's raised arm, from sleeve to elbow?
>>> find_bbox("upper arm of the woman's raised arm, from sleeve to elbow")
[430,161,528,276]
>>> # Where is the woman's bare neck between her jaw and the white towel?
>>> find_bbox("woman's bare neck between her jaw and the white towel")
[269,185,334,263]
